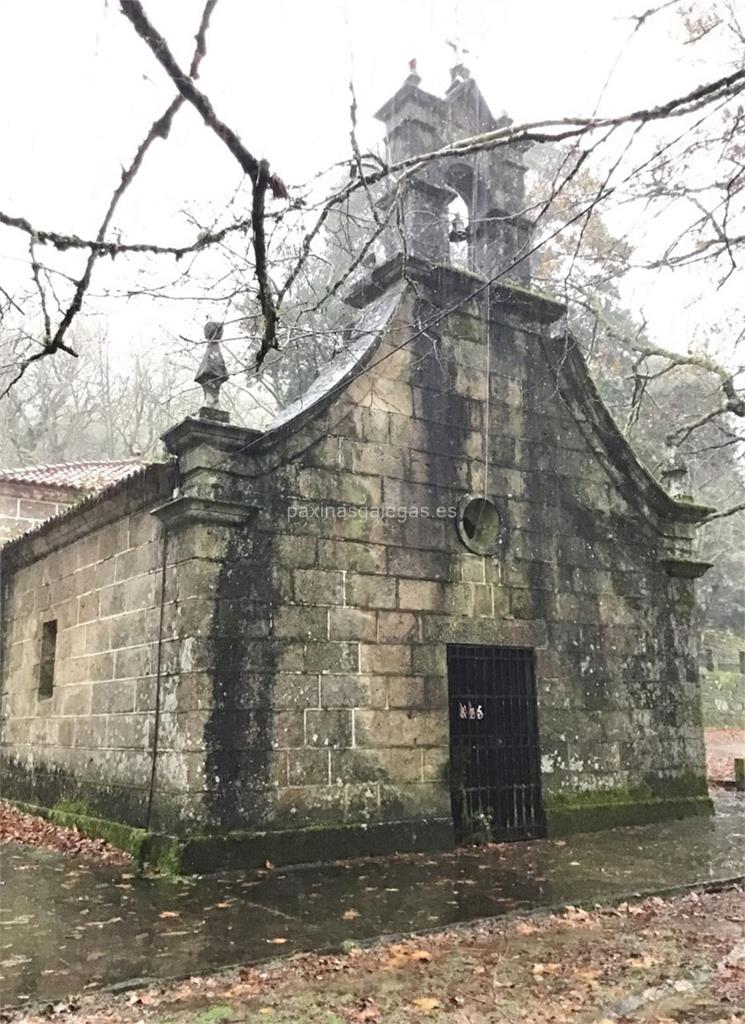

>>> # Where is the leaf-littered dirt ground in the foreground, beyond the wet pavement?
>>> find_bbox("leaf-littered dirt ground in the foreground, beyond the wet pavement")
[10,890,745,1024]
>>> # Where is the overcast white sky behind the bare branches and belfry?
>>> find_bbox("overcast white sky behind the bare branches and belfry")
[0,0,732,376]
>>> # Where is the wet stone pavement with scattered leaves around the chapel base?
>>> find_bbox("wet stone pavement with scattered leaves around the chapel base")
[0,792,745,1006]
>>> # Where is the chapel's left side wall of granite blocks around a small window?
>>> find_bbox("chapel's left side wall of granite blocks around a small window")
[0,466,187,823]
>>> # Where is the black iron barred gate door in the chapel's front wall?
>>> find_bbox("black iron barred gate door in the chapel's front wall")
[447,644,544,841]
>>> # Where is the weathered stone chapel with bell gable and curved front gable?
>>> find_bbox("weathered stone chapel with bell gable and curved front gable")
[0,66,711,871]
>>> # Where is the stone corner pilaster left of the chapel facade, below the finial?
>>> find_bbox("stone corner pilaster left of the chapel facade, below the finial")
[151,410,260,830]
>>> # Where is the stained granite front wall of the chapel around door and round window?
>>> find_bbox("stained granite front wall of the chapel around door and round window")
[174,276,704,828]
